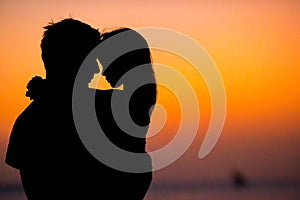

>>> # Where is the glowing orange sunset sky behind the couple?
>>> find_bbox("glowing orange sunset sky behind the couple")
[0,0,300,197]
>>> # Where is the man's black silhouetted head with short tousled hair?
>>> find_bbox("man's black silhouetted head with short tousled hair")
[41,18,100,73]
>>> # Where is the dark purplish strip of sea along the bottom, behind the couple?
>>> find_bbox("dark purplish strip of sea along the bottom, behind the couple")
[0,180,300,200]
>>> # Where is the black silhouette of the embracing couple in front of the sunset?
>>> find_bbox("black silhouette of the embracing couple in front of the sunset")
[6,19,156,200]
